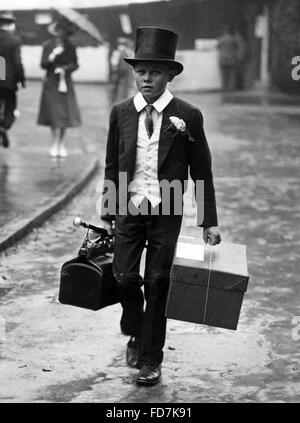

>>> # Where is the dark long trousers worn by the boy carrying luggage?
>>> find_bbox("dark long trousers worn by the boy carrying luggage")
[113,200,182,364]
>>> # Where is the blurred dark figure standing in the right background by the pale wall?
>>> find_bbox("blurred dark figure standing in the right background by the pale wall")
[218,26,237,91]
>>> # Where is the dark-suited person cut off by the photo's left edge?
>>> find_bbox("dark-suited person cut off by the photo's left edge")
[0,12,25,148]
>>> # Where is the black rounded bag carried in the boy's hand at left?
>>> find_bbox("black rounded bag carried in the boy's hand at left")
[58,219,119,310]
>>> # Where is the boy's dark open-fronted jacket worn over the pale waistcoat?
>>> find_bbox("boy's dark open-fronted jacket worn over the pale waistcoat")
[101,97,218,227]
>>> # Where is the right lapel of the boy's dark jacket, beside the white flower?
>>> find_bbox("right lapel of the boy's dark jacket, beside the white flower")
[157,98,179,171]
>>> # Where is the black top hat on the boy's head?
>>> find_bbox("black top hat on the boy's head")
[124,26,183,75]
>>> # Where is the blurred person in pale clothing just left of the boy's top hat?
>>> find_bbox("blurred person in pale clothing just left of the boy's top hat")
[110,37,134,103]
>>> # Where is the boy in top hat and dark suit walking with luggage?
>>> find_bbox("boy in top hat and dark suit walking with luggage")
[101,27,221,386]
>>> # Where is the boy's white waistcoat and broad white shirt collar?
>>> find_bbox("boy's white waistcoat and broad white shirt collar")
[129,89,173,207]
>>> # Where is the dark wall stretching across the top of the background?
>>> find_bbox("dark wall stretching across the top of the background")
[9,0,300,93]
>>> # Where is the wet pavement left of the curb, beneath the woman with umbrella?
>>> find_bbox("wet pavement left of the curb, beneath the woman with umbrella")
[0,81,108,250]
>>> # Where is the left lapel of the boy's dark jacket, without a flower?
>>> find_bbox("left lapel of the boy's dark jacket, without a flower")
[121,100,139,181]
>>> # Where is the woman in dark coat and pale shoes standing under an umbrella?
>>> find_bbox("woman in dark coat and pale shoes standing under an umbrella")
[38,21,81,158]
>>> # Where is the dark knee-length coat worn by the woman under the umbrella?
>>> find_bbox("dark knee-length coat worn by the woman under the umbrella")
[38,39,81,128]
